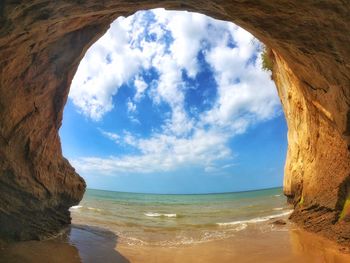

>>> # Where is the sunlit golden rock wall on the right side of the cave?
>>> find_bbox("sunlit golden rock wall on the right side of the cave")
[273,54,350,244]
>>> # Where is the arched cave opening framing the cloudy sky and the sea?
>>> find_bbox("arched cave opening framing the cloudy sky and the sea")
[60,6,291,250]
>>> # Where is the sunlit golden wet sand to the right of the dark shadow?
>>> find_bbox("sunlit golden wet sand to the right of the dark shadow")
[118,226,350,263]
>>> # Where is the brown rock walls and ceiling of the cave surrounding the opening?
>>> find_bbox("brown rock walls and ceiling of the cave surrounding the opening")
[0,0,350,242]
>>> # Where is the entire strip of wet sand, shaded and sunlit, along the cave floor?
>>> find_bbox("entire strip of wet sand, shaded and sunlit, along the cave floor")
[0,226,350,263]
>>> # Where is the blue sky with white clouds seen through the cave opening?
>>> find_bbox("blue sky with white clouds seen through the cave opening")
[60,9,287,194]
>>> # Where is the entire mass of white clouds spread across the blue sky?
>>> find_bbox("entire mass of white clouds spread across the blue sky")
[69,9,280,174]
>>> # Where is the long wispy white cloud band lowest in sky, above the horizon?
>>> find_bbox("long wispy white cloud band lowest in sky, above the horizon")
[72,130,232,175]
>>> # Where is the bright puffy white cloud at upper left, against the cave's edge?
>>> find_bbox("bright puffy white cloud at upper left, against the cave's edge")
[69,17,151,120]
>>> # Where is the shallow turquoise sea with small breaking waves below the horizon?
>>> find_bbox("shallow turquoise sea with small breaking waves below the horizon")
[70,188,291,245]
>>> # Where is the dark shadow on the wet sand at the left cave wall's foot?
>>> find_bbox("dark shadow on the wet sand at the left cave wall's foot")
[0,225,129,263]
